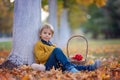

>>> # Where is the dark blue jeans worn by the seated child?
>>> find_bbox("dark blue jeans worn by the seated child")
[45,48,94,71]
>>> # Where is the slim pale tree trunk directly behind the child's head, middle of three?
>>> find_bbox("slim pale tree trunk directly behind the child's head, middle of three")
[48,0,58,44]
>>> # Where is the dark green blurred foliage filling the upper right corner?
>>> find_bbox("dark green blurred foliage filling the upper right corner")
[82,0,120,39]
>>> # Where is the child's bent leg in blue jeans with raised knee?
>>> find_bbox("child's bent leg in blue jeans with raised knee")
[45,48,77,72]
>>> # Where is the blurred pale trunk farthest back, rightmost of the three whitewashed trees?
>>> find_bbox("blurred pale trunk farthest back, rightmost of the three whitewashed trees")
[59,8,70,48]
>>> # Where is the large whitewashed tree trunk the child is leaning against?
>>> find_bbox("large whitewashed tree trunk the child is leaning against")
[2,0,41,68]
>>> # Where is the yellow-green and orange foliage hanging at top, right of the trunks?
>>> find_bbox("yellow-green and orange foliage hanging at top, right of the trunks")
[68,0,106,29]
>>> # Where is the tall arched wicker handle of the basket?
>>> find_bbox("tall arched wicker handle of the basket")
[67,35,88,62]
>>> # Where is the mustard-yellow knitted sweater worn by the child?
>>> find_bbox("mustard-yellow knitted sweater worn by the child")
[34,41,55,64]
